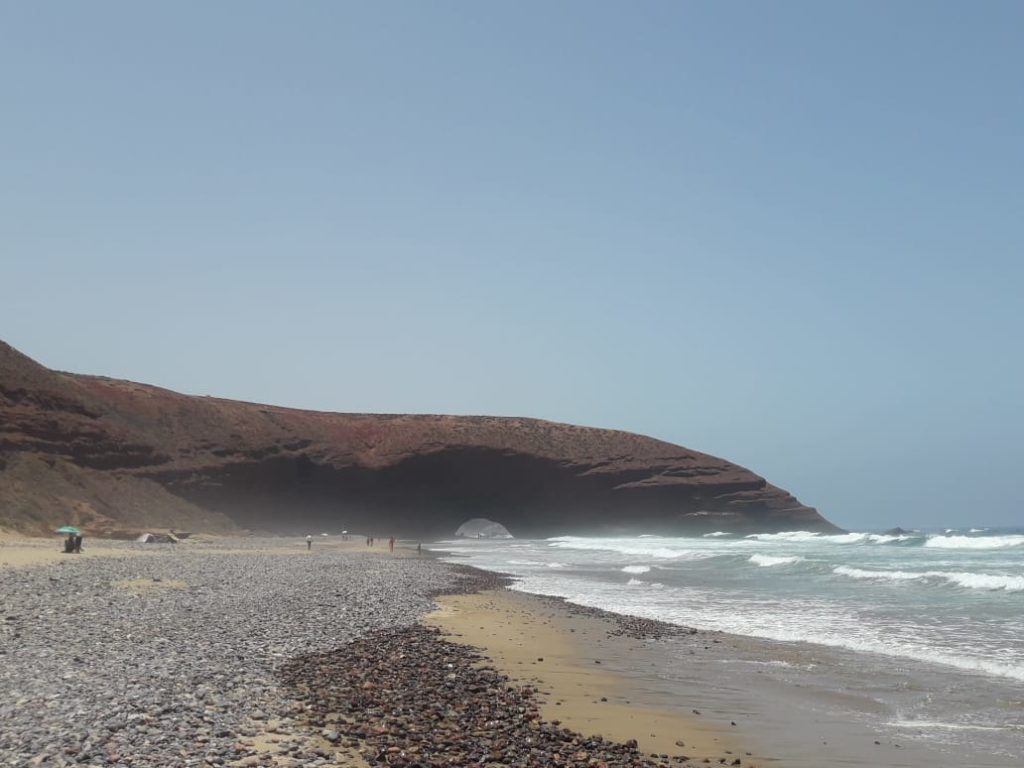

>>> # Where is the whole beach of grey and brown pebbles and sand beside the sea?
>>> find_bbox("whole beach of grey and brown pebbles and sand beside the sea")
[0,537,1000,768]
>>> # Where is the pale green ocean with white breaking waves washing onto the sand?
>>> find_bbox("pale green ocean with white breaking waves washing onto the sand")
[431,527,1024,765]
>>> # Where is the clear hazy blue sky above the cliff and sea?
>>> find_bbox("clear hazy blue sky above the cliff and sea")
[0,0,1024,529]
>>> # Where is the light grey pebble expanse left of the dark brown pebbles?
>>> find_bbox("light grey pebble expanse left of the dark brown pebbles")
[0,540,483,766]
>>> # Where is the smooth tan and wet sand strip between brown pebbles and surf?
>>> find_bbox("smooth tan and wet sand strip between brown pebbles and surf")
[426,566,1007,768]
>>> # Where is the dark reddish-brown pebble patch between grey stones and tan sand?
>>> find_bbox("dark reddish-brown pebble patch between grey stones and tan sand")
[281,626,687,768]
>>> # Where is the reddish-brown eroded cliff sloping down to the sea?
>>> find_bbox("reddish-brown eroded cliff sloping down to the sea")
[0,342,836,538]
